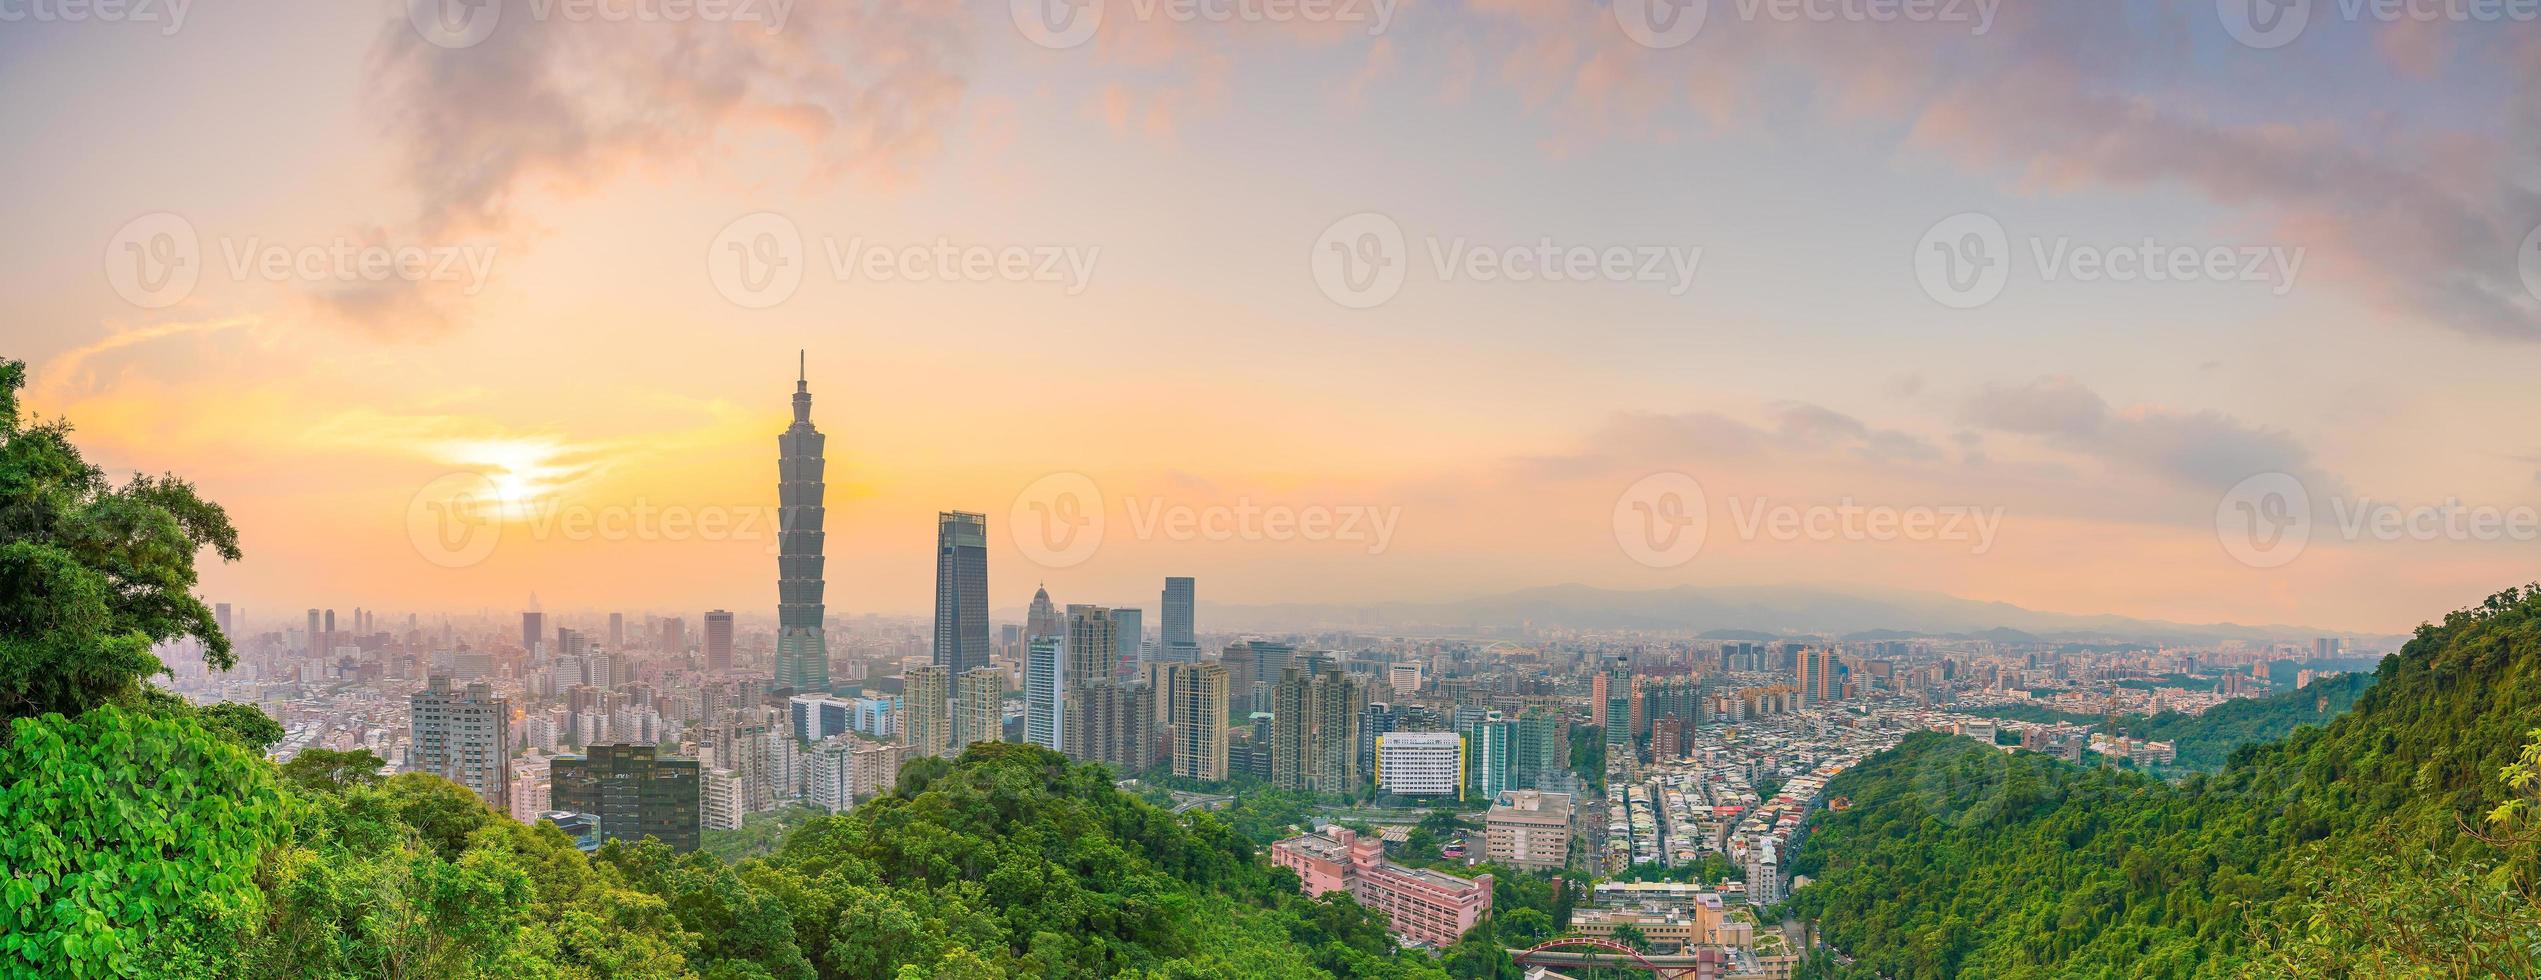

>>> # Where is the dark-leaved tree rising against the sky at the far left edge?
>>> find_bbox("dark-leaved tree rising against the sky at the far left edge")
[0,361,239,721]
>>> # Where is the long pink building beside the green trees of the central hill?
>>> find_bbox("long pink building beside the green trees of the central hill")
[1271,828,1492,947]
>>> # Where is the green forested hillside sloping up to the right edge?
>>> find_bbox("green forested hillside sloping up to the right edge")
[1789,589,2541,977]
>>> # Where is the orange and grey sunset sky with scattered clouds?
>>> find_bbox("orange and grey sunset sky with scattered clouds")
[0,0,2541,632]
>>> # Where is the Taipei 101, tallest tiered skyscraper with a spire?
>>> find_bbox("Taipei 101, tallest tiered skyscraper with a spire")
[778,347,828,693]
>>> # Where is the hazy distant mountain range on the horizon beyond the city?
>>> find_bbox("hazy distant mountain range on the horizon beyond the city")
[1179,584,2404,650]
